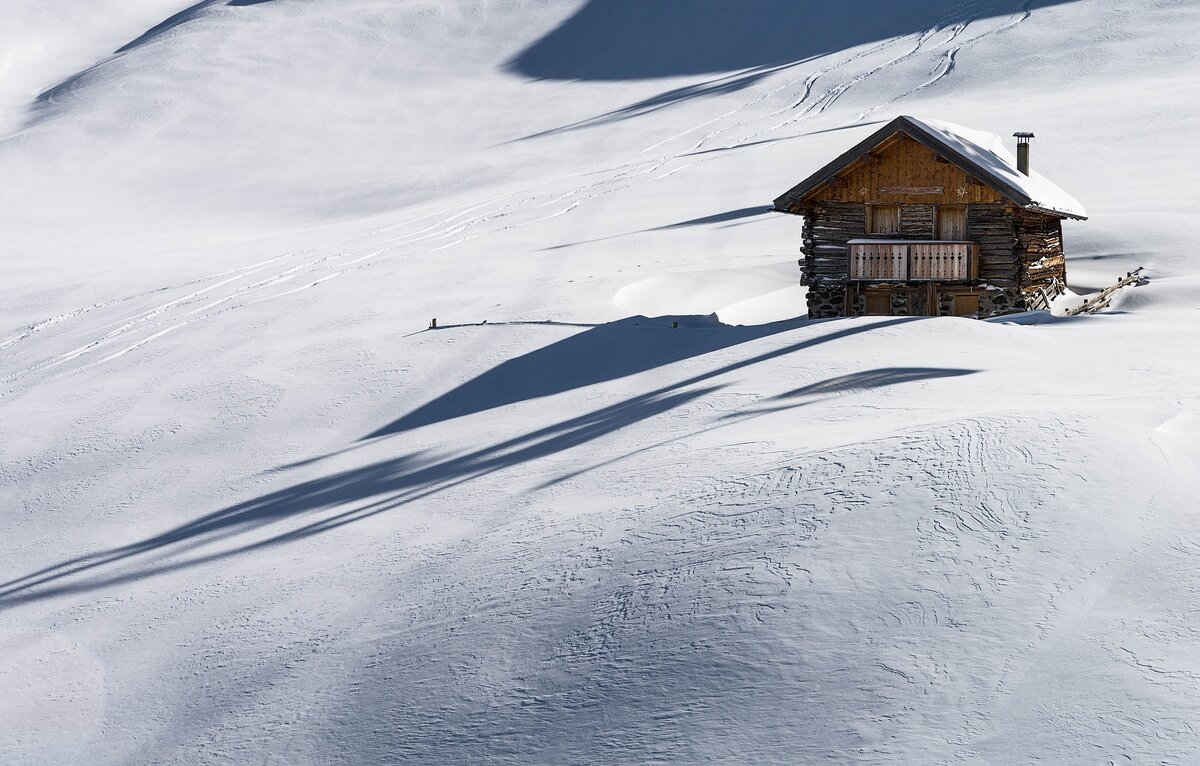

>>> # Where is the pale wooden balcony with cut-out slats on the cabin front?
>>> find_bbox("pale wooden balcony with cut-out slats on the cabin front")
[850,239,979,282]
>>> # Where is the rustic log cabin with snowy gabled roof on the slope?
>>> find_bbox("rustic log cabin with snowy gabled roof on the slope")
[775,116,1087,318]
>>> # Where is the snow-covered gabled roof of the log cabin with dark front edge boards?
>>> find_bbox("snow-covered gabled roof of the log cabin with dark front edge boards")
[775,115,1087,220]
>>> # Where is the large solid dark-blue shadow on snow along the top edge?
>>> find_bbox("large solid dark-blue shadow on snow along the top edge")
[505,0,1074,80]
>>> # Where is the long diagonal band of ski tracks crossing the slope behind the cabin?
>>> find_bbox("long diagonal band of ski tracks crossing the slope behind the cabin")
[0,0,1030,396]
